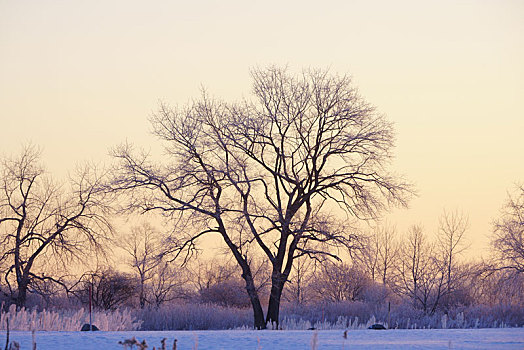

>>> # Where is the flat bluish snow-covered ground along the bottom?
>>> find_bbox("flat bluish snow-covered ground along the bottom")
[0,328,524,350]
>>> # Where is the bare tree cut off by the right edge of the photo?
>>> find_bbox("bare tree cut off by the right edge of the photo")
[491,186,524,273]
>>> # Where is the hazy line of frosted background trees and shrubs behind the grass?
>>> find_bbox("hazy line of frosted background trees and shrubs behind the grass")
[2,178,524,326]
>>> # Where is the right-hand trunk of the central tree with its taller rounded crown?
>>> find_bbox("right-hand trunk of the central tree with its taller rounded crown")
[223,68,408,326]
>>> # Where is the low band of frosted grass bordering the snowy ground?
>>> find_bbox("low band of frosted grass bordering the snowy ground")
[0,302,524,331]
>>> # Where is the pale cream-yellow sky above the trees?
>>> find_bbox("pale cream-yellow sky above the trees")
[0,0,524,254]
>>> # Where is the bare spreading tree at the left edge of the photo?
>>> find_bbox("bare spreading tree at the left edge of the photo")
[0,146,111,307]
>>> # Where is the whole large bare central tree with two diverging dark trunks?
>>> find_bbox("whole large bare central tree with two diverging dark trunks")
[113,67,410,328]
